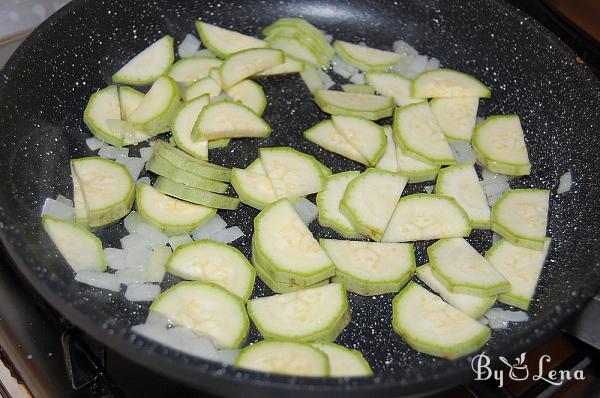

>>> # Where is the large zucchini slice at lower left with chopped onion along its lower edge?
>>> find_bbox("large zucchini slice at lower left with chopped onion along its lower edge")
[150,282,250,348]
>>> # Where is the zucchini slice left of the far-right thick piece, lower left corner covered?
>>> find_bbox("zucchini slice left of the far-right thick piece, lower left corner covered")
[435,163,491,229]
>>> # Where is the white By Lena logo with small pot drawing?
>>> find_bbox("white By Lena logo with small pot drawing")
[471,353,585,387]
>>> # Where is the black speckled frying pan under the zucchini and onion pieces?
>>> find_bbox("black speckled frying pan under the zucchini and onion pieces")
[0,0,600,397]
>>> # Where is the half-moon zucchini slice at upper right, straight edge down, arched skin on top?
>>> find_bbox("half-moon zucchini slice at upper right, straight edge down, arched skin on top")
[412,69,492,98]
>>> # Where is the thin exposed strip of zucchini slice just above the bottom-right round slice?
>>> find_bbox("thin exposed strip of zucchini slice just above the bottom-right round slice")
[417,263,497,319]
